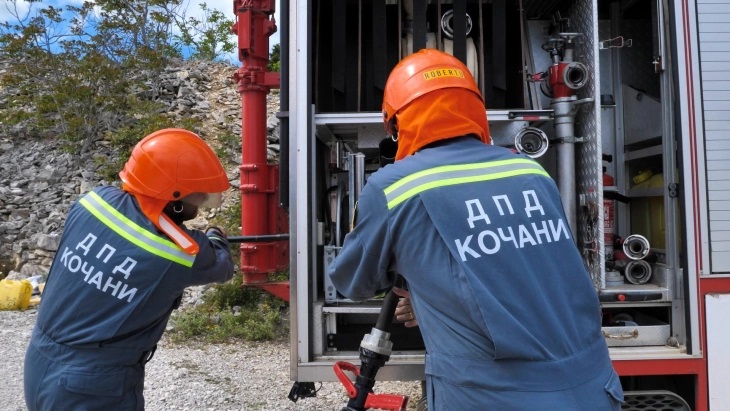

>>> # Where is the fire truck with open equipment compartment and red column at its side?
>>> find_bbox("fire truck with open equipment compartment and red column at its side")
[234,0,730,410]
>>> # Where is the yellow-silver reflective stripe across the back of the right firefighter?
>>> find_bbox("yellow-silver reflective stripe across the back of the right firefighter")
[384,158,550,209]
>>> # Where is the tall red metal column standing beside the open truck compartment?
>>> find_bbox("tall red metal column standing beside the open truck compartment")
[232,0,289,301]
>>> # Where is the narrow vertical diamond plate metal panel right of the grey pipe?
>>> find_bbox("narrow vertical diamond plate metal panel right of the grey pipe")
[569,0,605,288]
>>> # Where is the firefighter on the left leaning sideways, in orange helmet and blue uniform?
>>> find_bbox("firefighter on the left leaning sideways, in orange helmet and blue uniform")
[24,129,233,411]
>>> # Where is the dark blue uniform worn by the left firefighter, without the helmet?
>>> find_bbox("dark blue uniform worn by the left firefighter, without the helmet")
[25,187,234,411]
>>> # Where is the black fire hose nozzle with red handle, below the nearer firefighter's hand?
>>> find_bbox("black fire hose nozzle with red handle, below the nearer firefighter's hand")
[333,290,408,411]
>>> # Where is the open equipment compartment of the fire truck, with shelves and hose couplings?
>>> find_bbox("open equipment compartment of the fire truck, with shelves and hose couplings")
[282,0,699,408]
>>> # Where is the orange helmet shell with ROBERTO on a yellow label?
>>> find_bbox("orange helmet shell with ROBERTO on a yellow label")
[383,49,482,136]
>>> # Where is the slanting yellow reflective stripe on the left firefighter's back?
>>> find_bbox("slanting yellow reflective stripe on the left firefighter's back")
[79,192,195,267]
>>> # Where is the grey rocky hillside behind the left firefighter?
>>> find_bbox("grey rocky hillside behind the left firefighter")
[0,61,279,279]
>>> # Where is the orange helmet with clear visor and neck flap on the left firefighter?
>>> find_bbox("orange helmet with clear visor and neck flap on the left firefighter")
[119,128,230,254]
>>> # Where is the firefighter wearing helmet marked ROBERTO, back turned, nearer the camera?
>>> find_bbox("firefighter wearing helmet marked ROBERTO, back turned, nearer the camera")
[328,50,623,411]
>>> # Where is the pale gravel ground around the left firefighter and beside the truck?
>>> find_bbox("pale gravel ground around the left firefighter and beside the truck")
[0,308,421,411]
